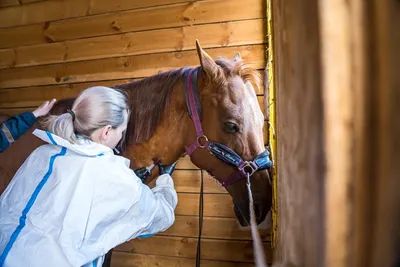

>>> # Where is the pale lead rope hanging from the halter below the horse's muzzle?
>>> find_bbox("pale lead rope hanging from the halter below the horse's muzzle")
[247,173,268,267]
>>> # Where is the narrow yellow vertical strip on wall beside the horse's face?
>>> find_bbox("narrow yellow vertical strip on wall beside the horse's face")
[266,0,278,249]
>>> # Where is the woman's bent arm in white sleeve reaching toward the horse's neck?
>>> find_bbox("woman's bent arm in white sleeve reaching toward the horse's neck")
[81,161,178,262]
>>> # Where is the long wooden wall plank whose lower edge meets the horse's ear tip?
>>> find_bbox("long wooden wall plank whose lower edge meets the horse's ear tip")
[0,19,265,68]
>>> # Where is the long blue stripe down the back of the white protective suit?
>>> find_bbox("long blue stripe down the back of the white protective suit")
[0,147,67,267]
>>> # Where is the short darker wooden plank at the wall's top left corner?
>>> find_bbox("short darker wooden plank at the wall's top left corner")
[0,0,90,28]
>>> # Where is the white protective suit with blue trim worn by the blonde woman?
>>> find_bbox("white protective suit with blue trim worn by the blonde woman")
[0,130,178,267]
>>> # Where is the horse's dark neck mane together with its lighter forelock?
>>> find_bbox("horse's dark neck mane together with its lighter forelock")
[113,58,261,149]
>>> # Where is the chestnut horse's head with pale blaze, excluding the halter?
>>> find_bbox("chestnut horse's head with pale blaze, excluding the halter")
[187,43,272,226]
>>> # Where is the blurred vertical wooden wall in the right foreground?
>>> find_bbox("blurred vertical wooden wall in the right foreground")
[272,0,400,267]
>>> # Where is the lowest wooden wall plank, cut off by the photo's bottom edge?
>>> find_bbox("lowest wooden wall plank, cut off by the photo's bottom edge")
[111,251,253,267]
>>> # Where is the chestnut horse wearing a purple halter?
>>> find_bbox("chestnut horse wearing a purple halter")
[0,41,272,266]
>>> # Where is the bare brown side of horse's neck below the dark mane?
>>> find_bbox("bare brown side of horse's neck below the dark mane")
[124,84,193,168]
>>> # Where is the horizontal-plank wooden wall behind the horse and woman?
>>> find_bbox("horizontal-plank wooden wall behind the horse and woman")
[0,0,270,267]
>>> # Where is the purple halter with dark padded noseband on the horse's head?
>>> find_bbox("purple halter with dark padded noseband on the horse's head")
[185,67,272,187]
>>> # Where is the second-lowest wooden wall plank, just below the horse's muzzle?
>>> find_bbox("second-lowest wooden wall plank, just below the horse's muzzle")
[115,236,272,262]
